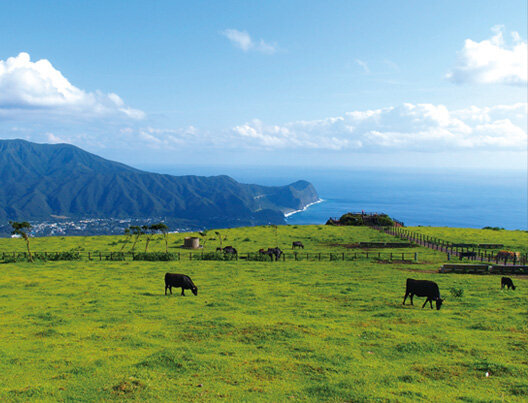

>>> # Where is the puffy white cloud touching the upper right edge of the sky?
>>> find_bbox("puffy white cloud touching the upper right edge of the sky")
[447,26,528,86]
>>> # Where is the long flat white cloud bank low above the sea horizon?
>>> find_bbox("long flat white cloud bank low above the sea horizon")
[226,103,528,152]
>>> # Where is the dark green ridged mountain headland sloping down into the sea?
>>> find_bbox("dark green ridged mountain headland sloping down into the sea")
[0,140,318,227]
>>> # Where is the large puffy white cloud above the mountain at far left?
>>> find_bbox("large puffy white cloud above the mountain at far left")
[0,52,144,119]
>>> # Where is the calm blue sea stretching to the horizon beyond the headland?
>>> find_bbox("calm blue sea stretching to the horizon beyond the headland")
[141,166,528,230]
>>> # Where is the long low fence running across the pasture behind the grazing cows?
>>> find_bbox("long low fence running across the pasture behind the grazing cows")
[0,251,418,263]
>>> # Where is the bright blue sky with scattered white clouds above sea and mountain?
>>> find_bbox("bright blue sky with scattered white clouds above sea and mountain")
[0,1,528,169]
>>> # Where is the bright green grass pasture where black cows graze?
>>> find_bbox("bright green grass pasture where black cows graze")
[0,226,528,402]
